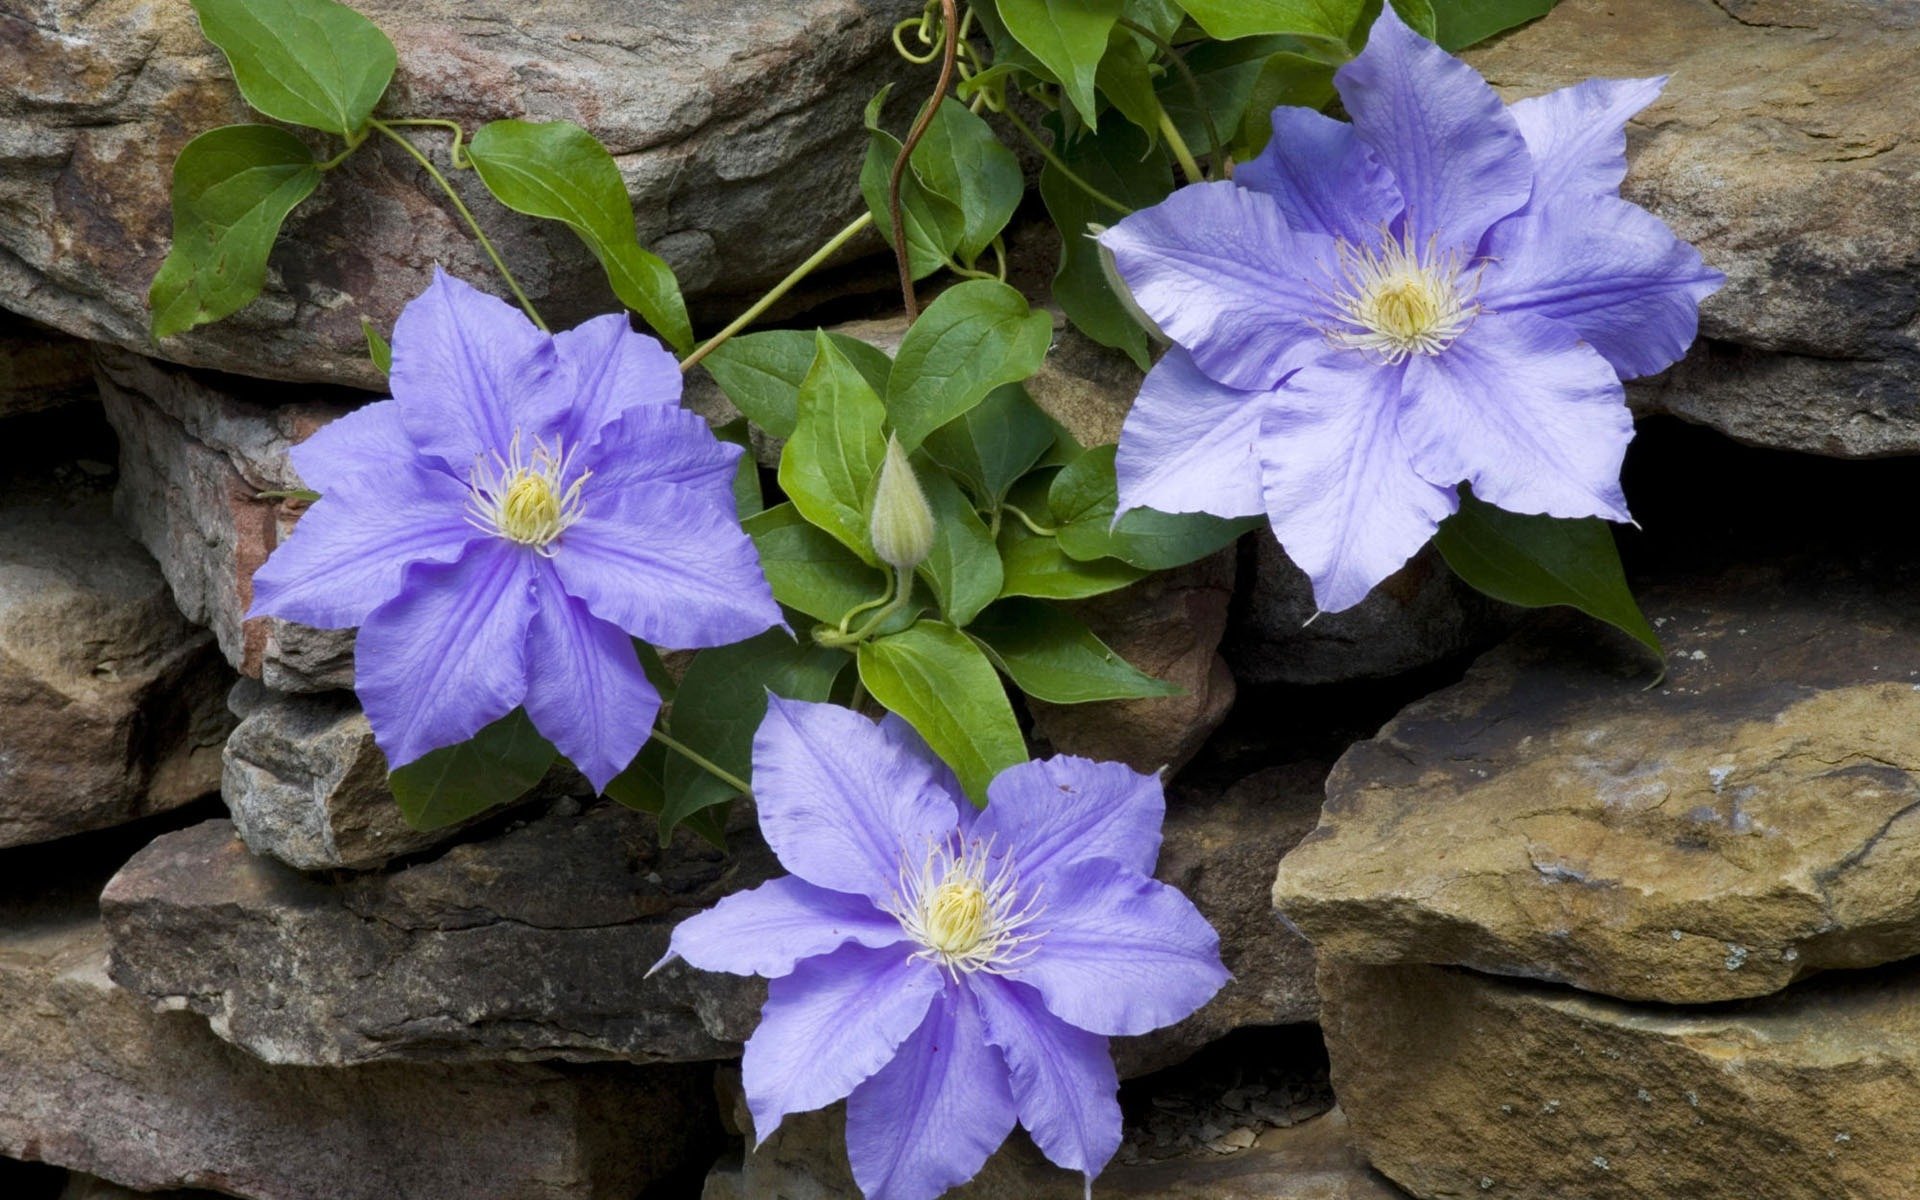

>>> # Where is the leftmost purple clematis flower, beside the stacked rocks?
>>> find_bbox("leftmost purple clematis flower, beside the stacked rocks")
[250,271,780,787]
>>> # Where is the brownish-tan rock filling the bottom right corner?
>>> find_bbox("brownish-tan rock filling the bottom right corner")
[1321,962,1920,1200]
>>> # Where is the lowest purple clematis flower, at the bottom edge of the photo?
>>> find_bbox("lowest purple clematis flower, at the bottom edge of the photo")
[655,697,1227,1200]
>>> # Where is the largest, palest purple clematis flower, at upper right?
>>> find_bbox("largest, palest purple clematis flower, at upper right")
[1100,4,1722,612]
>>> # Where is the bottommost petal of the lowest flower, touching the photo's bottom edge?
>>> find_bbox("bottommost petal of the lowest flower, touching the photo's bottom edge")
[847,987,1014,1200]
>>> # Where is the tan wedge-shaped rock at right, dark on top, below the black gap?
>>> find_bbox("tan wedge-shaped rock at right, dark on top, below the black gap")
[1273,564,1920,1002]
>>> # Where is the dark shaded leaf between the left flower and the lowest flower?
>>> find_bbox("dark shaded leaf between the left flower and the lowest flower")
[660,630,851,837]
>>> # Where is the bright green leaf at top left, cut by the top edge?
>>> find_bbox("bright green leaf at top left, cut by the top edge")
[194,0,394,136]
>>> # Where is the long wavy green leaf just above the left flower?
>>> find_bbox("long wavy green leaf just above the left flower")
[467,121,693,353]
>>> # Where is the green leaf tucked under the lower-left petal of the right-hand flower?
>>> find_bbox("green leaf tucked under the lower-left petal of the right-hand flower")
[1048,445,1261,570]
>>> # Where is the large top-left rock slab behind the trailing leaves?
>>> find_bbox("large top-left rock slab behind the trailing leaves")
[0,0,922,388]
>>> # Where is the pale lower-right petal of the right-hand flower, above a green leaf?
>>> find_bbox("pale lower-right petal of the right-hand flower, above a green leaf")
[1400,313,1634,520]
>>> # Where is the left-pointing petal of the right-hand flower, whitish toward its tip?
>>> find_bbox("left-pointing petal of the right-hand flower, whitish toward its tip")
[1100,182,1336,390]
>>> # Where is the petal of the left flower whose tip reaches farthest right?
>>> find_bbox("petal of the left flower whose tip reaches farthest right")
[553,484,780,649]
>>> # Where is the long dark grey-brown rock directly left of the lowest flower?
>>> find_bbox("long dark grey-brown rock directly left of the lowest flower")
[102,801,772,1066]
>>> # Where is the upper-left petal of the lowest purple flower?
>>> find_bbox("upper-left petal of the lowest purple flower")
[753,695,954,902]
